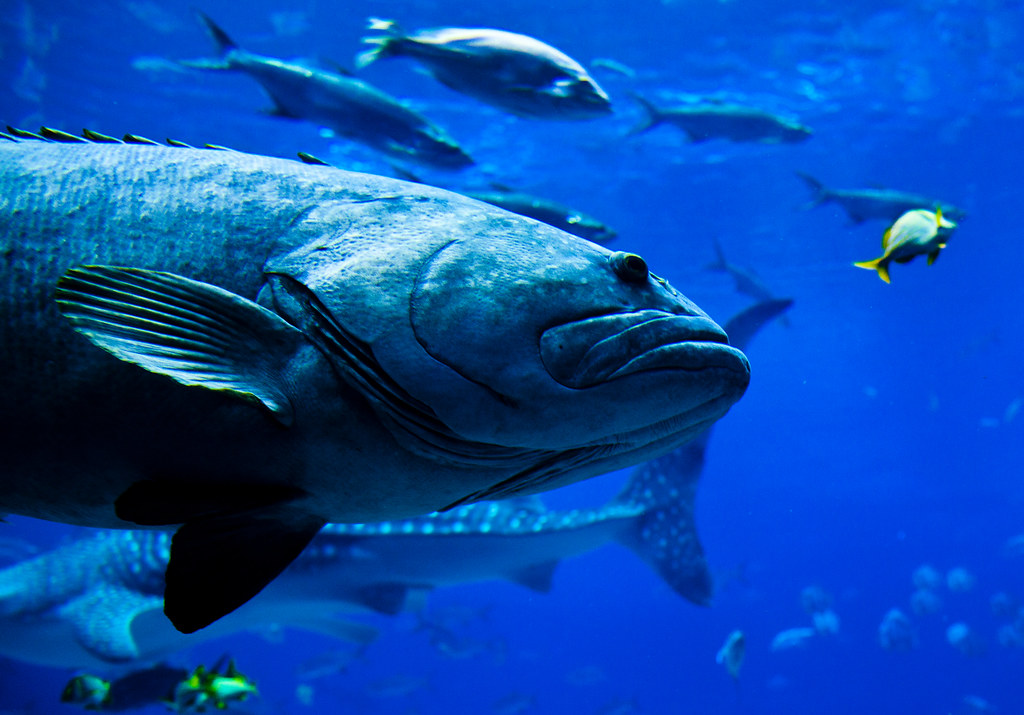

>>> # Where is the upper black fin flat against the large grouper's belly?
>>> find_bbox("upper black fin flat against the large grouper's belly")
[114,479,304,527]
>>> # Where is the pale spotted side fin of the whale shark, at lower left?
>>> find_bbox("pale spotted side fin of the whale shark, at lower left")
[60,586,164,663]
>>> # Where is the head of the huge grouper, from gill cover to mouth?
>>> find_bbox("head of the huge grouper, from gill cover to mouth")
[266,190,750,498]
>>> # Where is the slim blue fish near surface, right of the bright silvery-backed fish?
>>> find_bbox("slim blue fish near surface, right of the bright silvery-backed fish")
[630,94,811,143]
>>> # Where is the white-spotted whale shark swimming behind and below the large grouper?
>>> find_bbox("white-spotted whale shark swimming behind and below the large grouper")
[0,300,792,668]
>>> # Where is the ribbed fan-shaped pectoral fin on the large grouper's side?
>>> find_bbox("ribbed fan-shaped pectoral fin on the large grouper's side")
[56,265,303,426]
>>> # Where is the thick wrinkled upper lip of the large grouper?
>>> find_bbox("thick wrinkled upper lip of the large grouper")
[541,310,749,389]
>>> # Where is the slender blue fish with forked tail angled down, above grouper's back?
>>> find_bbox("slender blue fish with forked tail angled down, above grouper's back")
[182,12,473,169]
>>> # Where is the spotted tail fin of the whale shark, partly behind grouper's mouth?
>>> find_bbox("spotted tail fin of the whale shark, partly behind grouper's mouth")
[615,299,793,605]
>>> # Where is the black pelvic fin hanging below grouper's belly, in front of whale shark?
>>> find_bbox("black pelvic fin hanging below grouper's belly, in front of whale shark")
[164,507,326,633]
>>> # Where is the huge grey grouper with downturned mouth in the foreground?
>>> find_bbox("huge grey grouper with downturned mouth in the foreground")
[0,131,750,632]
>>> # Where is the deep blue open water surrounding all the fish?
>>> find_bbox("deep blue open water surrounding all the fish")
[0,0,1024,715]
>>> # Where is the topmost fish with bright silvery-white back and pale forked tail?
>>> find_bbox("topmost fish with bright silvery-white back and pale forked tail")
[355,17,611,119]
